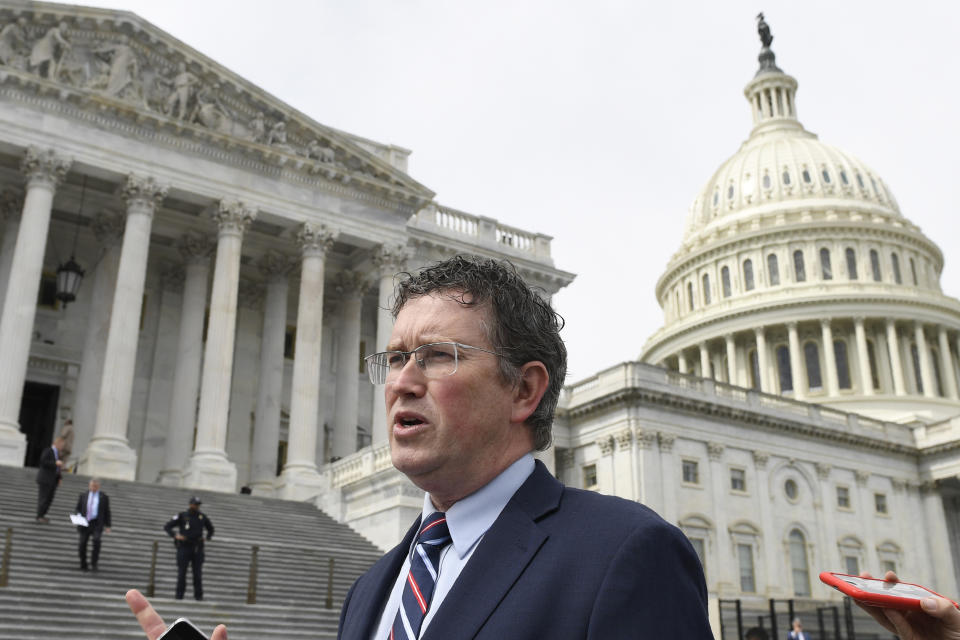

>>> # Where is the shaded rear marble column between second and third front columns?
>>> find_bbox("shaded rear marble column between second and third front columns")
[158,233,213,486]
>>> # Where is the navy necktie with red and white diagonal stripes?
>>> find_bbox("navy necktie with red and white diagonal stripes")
[390,512,450,640]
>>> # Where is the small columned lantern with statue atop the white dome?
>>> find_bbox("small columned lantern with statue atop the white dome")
[743,13,803,135]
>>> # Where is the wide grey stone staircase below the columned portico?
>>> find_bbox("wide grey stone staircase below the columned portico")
[0,466,381,640]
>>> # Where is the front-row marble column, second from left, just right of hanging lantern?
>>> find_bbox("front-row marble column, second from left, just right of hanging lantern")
[78,174,167,480]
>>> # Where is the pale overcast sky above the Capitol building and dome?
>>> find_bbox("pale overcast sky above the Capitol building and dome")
[95,0,960,382]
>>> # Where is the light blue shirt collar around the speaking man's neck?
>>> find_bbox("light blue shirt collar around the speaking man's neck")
[421,453,534,559]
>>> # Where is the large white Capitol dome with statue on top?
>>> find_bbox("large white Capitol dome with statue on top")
[641,23,960,422]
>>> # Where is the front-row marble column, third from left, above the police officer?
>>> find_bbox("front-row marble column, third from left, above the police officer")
[183,199,257,492]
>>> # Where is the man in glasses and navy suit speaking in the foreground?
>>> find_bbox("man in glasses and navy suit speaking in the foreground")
[127,256,713,640]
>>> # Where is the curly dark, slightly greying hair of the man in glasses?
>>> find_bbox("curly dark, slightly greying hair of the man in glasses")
[392,255,567,451]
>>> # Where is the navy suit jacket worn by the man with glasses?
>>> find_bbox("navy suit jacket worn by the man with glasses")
[338,462,713,640]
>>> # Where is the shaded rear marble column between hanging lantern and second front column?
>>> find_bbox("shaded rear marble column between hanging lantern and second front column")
[73,211,124,460]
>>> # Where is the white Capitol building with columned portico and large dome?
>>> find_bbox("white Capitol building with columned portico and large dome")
[0,2,960,620]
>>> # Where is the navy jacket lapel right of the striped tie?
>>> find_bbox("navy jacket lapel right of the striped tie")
[423,461,563,640]
